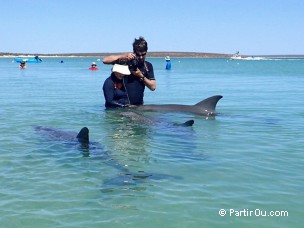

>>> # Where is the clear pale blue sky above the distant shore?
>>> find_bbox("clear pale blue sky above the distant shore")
[0,0,304,55]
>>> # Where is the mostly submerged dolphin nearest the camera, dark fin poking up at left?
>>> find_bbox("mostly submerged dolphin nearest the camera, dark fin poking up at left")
[34,126,181,185]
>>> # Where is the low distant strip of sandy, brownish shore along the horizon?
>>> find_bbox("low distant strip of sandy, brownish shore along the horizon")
[0,52,304,58]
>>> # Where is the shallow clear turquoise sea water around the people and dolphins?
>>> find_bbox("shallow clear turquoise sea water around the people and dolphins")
[0,58,304,227]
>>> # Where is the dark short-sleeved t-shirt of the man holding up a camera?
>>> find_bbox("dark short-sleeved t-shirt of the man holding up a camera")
[124,61,155,105]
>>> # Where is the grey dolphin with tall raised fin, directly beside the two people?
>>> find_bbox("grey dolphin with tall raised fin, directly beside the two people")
[136,95,223,116]
